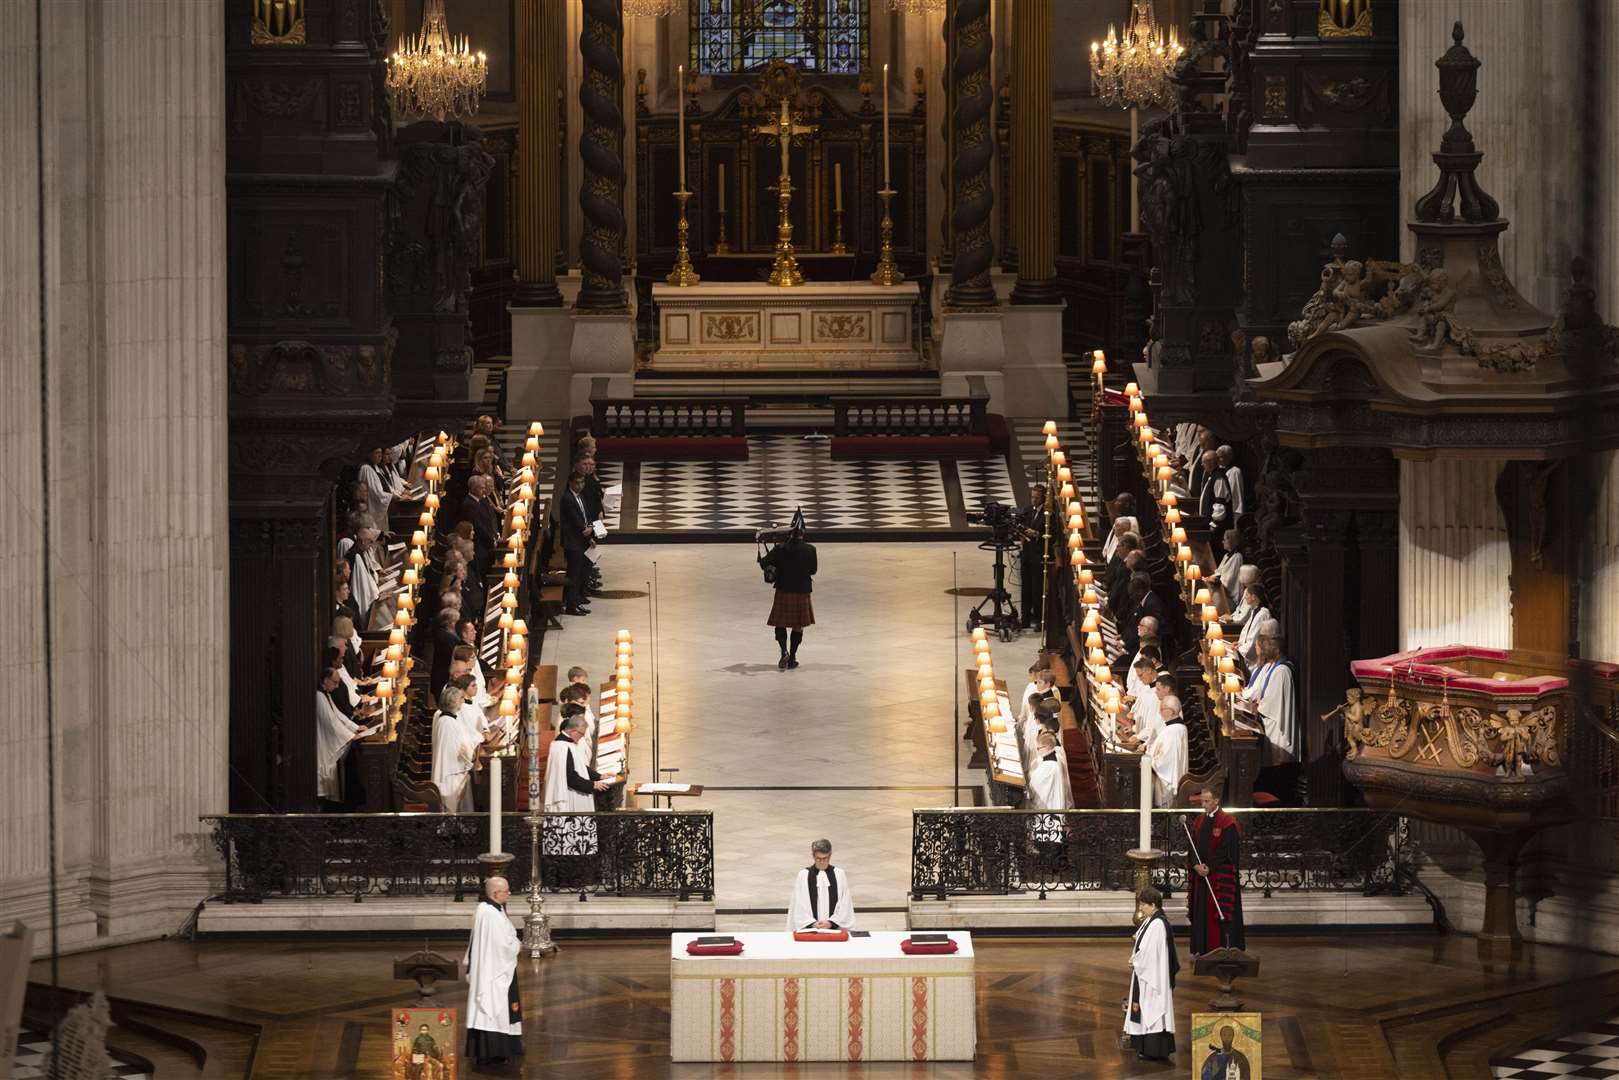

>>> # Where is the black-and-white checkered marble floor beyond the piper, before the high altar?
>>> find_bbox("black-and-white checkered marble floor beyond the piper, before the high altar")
[633,434,1012,533]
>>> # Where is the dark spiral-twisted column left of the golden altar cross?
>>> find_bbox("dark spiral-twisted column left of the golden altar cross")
[576,0,624,313]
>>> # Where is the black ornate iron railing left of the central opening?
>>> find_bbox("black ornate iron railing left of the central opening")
[202,810,714,904]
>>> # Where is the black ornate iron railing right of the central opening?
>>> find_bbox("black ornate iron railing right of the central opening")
[911,806,1405,900]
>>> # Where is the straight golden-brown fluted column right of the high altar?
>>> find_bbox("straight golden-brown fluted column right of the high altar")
[1012,0,1059,304]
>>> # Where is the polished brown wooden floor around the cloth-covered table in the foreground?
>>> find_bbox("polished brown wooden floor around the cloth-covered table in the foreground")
[22,936,1619,1080]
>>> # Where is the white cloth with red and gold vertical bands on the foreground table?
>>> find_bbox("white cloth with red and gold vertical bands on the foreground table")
[669,931,978,1061]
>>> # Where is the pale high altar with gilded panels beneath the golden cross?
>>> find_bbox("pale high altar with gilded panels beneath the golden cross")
[648,282,926,372]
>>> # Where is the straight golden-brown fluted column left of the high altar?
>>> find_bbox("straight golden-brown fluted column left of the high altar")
[512,0,563,308]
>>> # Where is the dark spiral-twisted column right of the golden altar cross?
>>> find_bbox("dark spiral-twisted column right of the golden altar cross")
[944,0,996,311]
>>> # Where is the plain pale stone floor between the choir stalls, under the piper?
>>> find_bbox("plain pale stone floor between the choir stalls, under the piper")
[541,542,990,929]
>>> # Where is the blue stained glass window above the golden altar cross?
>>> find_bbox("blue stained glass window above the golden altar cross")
[691,0,871,74]
